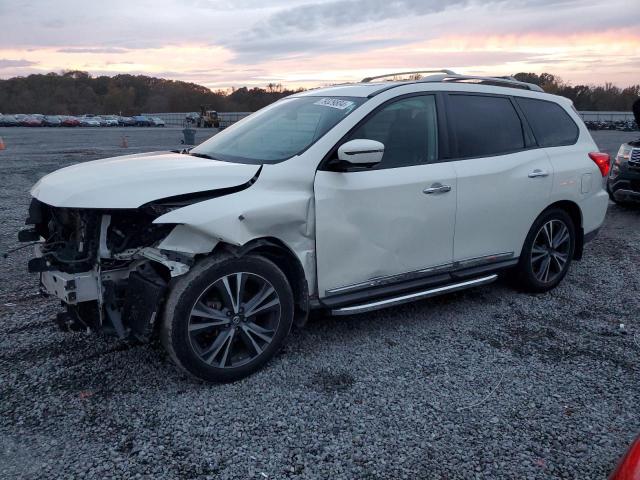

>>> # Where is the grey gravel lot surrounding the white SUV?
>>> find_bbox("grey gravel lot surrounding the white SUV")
[0,128,640,479]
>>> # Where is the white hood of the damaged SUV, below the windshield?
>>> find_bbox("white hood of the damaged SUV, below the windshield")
[31,152,260,208]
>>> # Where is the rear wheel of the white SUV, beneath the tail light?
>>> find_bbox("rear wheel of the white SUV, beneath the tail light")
[516,209,576,293]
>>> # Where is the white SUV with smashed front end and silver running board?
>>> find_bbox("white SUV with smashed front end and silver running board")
[20,71,609,381]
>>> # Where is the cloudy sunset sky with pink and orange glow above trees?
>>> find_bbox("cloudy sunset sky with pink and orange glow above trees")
[0,0,640,89]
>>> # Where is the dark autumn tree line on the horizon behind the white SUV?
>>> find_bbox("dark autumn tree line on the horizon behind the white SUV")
[0,71,640,115]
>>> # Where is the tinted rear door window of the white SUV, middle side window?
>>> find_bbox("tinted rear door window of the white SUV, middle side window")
[449,95,524,158]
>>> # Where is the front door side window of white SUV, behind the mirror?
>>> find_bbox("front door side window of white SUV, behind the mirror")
[348,95,438,168]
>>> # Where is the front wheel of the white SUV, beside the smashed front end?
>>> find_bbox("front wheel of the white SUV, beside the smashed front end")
[160,255,294,382]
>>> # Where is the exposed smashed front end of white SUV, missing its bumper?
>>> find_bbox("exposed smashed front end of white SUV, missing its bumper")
[19,199,194,341]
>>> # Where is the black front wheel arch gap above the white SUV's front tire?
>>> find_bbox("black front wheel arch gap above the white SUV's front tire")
[211,237,310,327]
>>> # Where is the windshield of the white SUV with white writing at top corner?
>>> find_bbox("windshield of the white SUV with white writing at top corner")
[190,97,366,164]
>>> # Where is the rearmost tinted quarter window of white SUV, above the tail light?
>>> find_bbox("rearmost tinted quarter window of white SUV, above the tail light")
[516,98,578,147]
